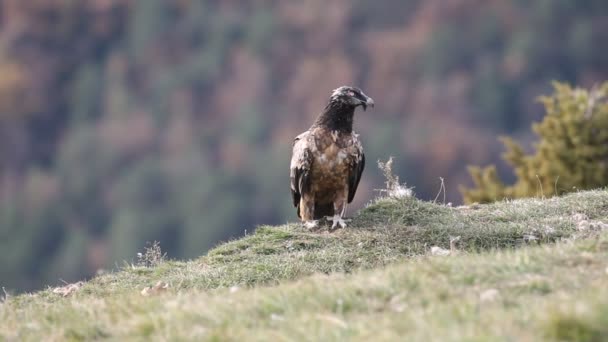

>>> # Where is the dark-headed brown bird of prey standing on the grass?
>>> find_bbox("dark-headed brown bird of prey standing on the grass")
[290,86,374,230]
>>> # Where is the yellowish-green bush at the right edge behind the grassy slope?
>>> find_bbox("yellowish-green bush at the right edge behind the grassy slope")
[460,82,608,203]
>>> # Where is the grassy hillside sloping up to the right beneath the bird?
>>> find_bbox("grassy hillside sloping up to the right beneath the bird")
[0,190,608,341]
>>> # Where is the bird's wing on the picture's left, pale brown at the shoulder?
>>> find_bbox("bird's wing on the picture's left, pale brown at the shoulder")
[289,131,313,215]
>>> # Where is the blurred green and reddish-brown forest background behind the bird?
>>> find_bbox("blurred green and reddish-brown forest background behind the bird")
[0,0,608,291]
